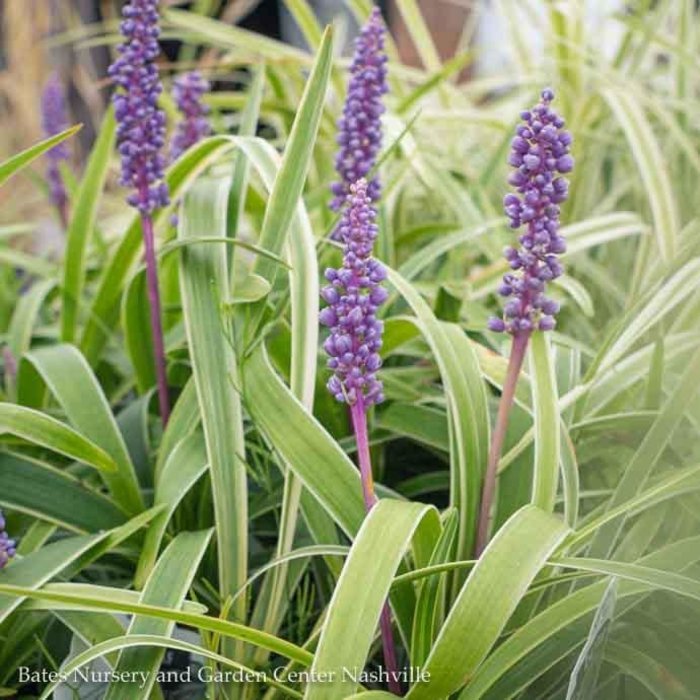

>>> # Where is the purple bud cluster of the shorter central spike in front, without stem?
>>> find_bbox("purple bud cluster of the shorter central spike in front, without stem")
[320,179,388,406]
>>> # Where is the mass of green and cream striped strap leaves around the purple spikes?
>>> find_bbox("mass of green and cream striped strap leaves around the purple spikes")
[0,0,700,700]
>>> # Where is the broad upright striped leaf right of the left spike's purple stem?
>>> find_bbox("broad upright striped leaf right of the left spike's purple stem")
[178,179,248,640]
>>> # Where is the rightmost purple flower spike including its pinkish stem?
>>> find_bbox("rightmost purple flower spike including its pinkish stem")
[482,88,574,557]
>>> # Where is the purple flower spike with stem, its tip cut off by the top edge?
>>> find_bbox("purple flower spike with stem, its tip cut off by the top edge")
[109,0,170,424]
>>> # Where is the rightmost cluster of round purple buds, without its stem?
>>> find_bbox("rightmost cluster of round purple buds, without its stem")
[489,89,574,335]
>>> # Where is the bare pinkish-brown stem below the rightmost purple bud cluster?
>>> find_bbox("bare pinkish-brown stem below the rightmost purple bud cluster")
[474,332,530,557]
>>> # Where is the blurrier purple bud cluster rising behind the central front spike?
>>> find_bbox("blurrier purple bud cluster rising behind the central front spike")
[331,8,388,235]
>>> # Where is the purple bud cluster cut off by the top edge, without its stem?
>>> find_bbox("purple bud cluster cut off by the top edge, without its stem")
[109,0,168,216]
